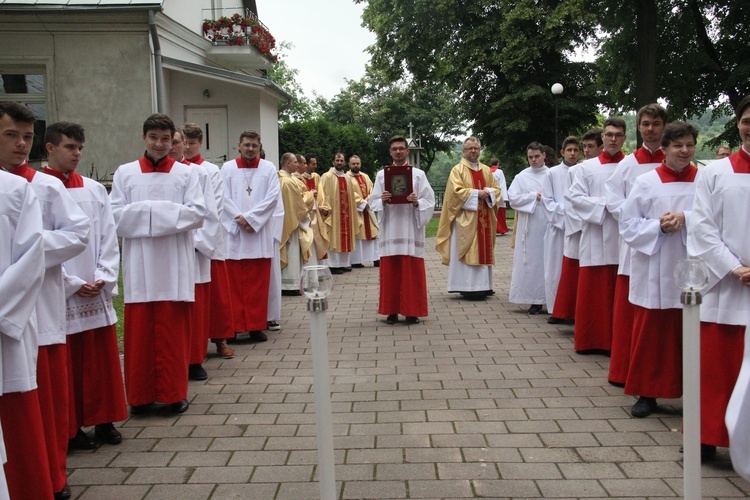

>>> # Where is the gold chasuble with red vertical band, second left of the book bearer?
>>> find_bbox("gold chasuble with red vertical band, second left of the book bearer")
[318,167,359,252]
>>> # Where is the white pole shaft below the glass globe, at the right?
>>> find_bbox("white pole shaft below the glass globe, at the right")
[682,291,701,500]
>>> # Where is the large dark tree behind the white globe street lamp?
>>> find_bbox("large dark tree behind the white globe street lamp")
[355,0,601,156]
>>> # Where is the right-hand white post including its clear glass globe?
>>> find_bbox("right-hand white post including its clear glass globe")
[674,259,708,499]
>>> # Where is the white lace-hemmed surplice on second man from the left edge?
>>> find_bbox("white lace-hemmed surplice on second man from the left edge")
[63,177,120,334]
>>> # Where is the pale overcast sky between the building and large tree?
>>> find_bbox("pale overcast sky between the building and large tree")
[258,0,375,99]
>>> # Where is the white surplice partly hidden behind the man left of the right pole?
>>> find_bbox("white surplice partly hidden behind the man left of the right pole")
[604,146,661,276]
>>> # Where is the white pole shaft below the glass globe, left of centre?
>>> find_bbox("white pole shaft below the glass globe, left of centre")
[308,299,336,500]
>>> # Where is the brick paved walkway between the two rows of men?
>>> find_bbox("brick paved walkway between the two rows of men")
[68,236,750,500]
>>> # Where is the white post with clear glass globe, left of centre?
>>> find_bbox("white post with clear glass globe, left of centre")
[299,266,337,500]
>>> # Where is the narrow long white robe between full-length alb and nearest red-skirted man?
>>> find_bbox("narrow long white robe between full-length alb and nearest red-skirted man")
[542,162,570,316]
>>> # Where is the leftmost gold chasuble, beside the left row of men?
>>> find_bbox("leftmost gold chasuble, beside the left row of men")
[279,170,313,269]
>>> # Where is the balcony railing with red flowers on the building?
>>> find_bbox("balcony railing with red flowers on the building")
[203,9,277,62]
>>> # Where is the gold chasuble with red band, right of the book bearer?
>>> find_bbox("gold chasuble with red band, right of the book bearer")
[435,158,500,266]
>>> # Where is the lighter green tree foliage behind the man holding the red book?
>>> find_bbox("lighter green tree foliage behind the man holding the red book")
[319,68,466,172]
